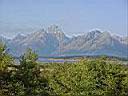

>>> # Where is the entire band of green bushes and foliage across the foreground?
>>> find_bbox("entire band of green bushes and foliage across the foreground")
[0,43,128,96]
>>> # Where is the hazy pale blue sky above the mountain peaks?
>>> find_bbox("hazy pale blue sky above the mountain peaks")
[0,0,127,37]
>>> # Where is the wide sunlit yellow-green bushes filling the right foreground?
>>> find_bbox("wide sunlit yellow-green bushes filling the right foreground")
[45,59,128,96]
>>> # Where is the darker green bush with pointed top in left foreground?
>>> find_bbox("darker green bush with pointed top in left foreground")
[0,49,50,96]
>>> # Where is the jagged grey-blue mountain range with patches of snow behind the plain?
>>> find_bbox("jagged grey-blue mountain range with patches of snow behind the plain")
[0,25,128,57]
